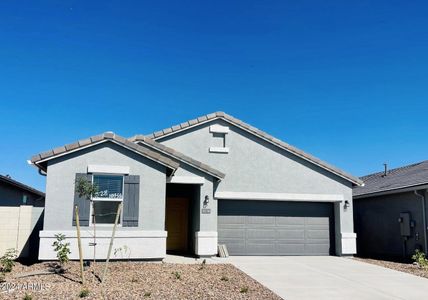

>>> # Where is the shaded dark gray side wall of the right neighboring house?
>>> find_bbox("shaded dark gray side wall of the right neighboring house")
[354,192,424,258]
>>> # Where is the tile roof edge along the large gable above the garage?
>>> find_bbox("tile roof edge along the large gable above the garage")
[135,112,363,185]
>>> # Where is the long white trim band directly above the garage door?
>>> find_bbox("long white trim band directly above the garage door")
[214,192,345,202]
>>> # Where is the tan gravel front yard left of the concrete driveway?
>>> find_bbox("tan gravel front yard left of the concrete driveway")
[0,262,281,299]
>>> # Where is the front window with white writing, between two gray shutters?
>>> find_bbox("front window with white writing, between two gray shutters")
[91,175,123,224]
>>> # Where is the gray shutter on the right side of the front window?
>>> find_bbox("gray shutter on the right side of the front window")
[122,175,140,227]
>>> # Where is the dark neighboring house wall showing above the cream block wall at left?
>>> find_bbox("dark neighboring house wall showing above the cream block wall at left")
[0,181,44,206]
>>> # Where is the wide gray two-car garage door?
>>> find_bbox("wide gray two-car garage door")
[218,200,334,255]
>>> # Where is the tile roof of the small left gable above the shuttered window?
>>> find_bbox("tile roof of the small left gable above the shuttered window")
[31,132,180,171]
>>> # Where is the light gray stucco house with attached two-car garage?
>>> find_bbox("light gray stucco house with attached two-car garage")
[32,112,362,259]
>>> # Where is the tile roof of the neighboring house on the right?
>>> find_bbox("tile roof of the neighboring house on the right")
[353,161,428,196]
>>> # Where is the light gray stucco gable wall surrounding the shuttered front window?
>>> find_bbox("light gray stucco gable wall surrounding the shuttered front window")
[44,142,166,231]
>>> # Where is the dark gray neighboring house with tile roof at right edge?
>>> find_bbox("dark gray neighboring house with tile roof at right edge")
[353,161,428,259]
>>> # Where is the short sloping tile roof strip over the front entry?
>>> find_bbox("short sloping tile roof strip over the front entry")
[130,135,226,179]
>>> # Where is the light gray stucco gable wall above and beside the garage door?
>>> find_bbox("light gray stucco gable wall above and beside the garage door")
[157,120,353,234]
